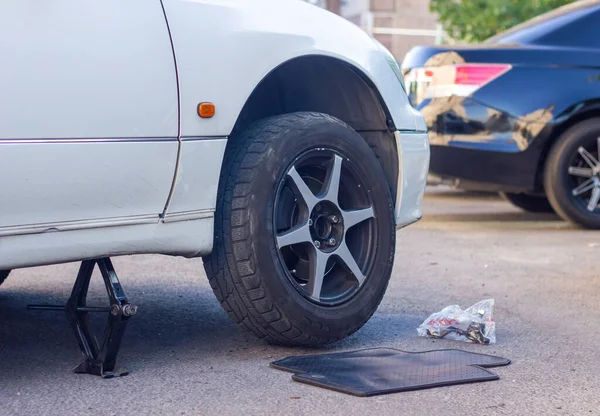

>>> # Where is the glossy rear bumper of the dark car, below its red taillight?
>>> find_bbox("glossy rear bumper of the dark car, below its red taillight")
[419,97,551,192]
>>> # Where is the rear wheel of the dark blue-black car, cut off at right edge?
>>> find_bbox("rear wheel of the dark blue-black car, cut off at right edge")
[544,118,600,229]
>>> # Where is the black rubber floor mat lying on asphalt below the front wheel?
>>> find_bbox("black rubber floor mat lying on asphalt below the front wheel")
[271,348,510,396]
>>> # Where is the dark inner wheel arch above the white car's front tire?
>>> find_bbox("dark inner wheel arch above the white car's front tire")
[224,55,399,200]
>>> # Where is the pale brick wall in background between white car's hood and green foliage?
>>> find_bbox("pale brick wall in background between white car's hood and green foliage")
[371,0,437,61]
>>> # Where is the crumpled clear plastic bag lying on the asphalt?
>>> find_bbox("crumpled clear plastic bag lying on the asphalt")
[417,299,496,344]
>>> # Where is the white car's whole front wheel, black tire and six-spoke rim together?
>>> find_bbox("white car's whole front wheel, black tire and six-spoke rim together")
[204,113,395,345]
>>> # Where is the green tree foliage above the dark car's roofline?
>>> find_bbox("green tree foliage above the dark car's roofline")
[429,0,573,42]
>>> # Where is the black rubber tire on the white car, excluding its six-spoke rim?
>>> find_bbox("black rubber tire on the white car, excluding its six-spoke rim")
[204,113,395,346]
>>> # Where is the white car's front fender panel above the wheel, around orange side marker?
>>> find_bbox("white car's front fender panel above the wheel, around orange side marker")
[164,0,422,137]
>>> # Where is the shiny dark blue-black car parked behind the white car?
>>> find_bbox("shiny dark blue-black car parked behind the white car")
[402,0,600,228]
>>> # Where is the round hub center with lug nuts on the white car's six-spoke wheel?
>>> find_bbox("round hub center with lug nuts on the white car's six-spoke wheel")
[309,201,344,252]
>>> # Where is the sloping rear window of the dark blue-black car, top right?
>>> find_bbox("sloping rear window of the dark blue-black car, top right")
[485,0,600,47]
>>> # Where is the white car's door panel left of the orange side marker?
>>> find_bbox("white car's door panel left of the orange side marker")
[0,0,179,232]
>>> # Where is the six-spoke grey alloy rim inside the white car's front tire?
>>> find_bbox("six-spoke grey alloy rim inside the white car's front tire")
[273,149,376,306]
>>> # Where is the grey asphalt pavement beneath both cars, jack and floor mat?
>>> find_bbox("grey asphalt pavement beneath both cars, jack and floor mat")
[0,188,600,416]
